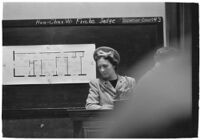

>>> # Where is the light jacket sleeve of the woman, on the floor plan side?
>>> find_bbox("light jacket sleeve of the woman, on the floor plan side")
[85,81,101,110]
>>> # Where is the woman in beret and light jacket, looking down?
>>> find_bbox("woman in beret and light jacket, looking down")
[86,47,135,110]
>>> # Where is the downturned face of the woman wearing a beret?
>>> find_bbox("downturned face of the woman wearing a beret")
[97,57,115,80]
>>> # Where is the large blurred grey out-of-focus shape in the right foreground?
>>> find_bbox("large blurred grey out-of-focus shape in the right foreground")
[104,48,193,138]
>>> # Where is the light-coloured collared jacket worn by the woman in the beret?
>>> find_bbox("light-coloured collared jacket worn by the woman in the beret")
[85,75,136,110]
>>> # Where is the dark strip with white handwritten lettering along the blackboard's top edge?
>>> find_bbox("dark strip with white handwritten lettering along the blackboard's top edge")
[3,17,162,27]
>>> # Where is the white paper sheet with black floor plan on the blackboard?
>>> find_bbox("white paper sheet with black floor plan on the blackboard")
[3,44,96,84]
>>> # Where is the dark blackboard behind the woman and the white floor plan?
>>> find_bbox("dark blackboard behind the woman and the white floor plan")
[3,17,163,115]
